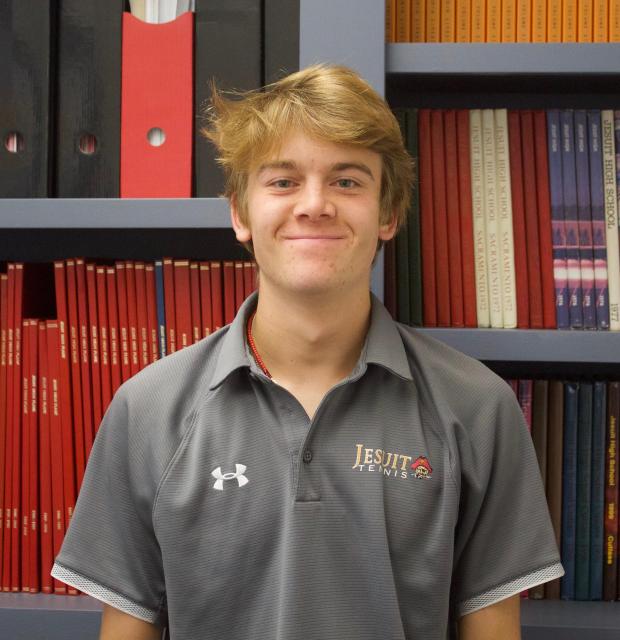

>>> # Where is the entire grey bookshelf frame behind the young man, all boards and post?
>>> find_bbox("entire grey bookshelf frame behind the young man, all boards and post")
[0,0,620,640]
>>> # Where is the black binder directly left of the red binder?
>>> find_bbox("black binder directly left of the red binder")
[53,0,125,198]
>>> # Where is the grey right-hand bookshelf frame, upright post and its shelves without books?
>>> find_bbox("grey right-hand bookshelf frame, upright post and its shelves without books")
[300,0,620,640]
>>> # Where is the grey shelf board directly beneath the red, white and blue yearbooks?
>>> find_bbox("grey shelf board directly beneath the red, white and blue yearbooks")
[417,328,620,367]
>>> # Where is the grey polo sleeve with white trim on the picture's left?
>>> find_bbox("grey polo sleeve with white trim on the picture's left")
[52,387,165,624]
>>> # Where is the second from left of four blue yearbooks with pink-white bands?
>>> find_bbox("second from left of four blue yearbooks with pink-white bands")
[560,109,583,329]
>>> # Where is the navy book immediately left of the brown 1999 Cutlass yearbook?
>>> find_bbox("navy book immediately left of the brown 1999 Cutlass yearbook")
[590,382,607,600]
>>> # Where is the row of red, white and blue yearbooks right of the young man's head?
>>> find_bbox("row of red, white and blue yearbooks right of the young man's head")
[385,109,620,330]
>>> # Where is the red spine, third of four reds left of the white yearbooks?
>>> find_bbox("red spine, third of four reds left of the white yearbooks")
[443,109,465,327]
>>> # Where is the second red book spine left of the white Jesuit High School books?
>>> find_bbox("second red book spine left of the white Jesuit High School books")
[431,109,451,327]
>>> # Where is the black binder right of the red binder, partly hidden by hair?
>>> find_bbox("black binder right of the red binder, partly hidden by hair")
[193,0,263,198]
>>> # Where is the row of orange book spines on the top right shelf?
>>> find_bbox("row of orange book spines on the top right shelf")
[385,0,620,42]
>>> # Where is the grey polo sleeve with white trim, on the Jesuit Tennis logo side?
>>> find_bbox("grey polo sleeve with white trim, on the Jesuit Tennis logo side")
[452,379,564,616]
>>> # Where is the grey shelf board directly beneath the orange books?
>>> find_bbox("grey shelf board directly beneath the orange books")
[385,43,620,76]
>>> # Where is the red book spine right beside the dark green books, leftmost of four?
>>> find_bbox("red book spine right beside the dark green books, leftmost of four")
[418,109,437,327]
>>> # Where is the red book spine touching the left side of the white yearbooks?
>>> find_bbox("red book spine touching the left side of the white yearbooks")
[456,109,478,327]
